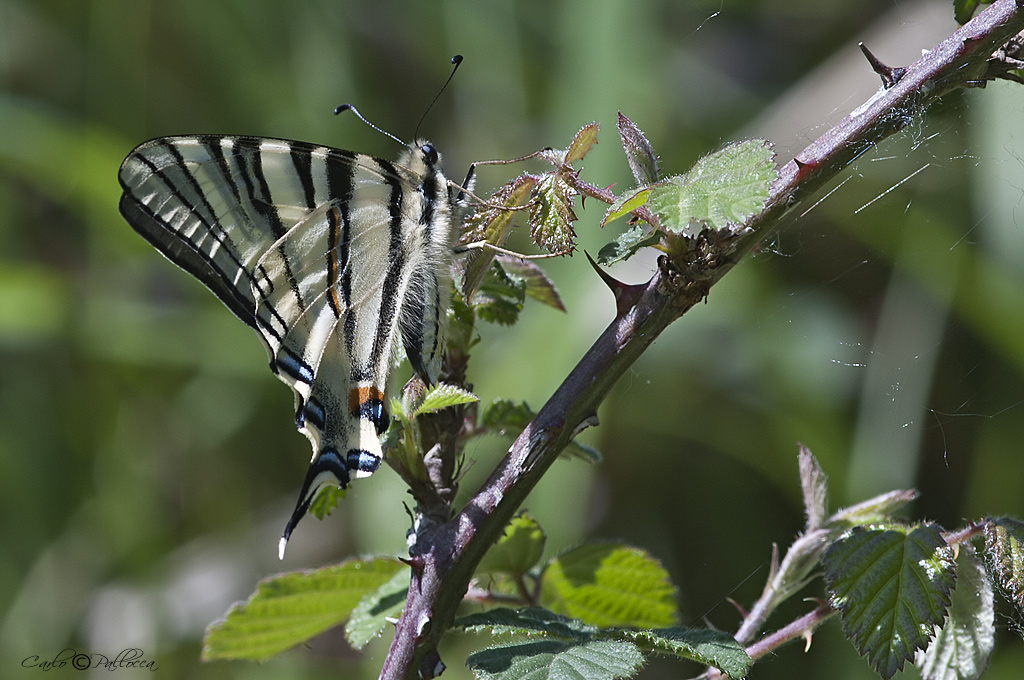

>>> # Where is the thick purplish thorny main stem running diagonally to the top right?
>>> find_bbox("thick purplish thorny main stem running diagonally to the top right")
[381,0,1024,680]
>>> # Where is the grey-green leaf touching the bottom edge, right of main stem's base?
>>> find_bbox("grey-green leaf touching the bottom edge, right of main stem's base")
[466,640,644,680]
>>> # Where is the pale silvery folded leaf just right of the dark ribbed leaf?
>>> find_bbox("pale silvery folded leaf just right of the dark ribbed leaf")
[913,544,995,680]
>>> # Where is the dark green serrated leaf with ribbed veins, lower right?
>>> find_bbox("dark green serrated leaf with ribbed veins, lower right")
[822,524,955,680]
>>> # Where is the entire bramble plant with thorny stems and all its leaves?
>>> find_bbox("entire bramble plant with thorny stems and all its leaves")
[204,0,1024,680]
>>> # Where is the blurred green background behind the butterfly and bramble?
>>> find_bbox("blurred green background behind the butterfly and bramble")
[0,0,1024,680]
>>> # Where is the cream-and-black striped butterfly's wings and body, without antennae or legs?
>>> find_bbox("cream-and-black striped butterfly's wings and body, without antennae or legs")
[119,135,453,555]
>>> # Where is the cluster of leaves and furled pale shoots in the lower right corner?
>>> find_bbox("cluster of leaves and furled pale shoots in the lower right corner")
[765,450,1024,680]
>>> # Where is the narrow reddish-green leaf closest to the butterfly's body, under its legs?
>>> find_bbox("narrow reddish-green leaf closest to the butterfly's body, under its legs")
[459,174,539,300]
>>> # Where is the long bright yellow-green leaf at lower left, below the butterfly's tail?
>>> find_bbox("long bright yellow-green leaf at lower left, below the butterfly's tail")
[203,558,406,661]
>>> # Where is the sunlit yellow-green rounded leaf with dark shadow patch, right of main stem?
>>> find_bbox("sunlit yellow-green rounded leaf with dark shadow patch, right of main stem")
[541,544,679,628]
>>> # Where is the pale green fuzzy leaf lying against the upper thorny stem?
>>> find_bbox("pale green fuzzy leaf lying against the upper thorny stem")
[649,139,778,236]
